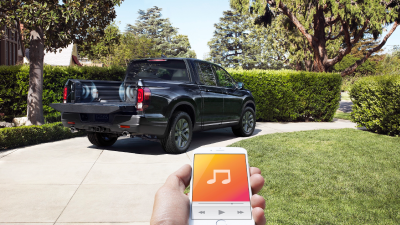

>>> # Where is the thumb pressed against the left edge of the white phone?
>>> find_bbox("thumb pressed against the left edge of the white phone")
[164,164,192,193]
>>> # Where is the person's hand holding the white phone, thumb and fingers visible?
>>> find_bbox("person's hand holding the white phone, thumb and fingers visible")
[150,164,266,225]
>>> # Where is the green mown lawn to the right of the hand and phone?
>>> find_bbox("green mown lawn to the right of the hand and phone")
[231,129,400,224]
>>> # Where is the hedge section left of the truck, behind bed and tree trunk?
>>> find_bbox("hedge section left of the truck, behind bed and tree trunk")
[0,65,125,121]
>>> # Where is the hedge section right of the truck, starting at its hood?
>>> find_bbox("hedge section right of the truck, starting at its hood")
[228,70,342,121]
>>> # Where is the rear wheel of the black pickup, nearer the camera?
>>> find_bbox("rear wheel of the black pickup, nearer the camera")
[160,111,193,154]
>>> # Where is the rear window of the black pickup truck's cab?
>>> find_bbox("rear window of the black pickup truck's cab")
[126,59,189,81]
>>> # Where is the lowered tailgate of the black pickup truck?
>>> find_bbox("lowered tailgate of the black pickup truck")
[50,103,136,114]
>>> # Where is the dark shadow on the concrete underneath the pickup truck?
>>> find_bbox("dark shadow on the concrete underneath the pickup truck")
[88,127,261,155]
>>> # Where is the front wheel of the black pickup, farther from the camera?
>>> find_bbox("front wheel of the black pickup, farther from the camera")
[232,107,256,137]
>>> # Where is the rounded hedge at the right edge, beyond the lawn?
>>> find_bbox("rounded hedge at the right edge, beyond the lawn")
[350,74,400,135]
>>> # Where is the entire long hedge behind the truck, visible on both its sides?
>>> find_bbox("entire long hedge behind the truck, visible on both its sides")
[0,66,342,122]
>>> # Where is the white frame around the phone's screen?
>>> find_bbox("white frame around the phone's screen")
[189,147,254,225]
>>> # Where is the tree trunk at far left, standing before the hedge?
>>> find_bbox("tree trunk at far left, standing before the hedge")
[27,27,44,125]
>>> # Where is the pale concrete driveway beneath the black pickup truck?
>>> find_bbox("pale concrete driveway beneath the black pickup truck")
[0,120,355,225]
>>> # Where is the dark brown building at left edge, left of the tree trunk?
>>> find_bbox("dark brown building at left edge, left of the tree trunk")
[0,23,25,66]
